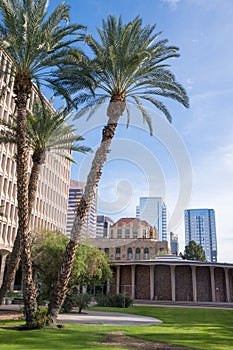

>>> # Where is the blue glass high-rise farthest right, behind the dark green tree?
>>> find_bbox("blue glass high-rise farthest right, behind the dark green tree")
[184,209,217,262]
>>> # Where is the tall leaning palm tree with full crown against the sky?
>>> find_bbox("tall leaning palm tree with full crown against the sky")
[48,16,188,322]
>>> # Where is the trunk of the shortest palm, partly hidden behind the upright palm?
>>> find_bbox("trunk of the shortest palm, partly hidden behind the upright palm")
[0,157,44,305]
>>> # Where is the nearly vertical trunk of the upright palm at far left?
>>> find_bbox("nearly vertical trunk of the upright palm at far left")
[15,85,37,328]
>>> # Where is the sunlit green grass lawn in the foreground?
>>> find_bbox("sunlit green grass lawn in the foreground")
[0,306,233,350]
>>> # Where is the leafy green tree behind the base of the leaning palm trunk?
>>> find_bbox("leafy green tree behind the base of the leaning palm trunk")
[32,231,112,300]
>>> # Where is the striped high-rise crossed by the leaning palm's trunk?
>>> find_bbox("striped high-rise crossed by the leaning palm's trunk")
[66,180,97,240]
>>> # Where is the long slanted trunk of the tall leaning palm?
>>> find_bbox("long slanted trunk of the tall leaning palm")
[48,96,125,324]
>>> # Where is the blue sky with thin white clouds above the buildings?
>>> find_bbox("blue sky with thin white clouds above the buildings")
[50,0,233,262]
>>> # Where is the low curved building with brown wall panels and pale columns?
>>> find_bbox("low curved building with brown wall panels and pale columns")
[108,256,233,307]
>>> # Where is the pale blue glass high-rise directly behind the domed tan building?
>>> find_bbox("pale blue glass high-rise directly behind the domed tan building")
[136,197,168,241]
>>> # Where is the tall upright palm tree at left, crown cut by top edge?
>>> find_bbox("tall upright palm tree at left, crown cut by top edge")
[0,0,83,327]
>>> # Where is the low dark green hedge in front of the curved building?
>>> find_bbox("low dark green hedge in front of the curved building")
[95,294,132,307]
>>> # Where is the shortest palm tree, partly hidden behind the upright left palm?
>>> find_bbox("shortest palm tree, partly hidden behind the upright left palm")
[0,103,90,305]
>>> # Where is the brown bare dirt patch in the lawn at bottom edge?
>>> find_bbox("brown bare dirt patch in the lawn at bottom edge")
[102,332,191,350]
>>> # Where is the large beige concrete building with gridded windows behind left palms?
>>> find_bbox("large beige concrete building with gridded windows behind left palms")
[0,51,70,285]
